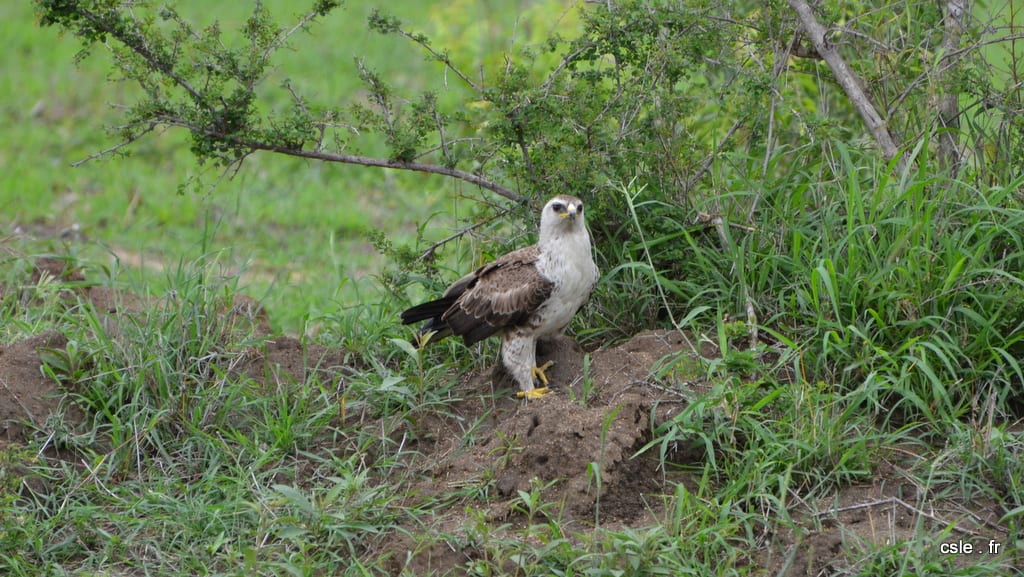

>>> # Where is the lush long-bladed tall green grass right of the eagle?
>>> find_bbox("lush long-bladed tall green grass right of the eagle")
[643,142,1024,424]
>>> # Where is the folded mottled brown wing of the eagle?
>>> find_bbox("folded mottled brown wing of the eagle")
[441,246,554,344]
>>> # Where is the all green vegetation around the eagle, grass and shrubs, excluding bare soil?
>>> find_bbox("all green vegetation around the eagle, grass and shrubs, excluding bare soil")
[0,0,1024,575]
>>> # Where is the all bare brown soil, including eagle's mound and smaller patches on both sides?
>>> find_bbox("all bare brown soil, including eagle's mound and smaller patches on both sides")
[0,259,1010,576]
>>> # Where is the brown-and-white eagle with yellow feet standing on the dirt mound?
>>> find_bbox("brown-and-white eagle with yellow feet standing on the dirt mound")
[401,195,599,399]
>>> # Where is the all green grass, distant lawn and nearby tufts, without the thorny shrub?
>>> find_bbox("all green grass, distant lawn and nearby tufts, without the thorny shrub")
[0,1,1024,576]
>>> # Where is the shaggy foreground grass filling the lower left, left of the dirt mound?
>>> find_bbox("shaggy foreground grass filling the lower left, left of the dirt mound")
[7,257,412,575]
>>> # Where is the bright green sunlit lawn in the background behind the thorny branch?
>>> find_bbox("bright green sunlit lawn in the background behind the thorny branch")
[0,1,512,333]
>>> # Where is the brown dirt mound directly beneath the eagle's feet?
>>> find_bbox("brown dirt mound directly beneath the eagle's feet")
[419,331,684,522]
